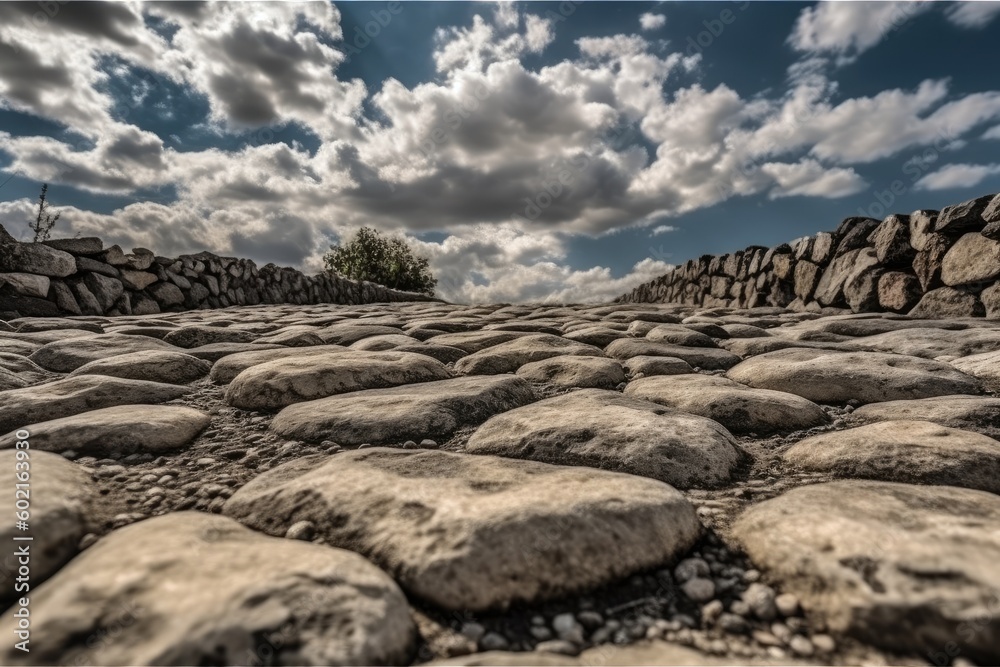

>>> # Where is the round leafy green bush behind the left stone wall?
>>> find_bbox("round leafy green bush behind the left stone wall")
[323,227,437,296]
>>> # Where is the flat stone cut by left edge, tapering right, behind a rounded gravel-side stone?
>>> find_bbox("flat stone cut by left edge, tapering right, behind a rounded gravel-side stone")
[0,375,189,432]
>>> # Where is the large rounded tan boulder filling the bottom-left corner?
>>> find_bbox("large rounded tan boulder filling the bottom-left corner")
[0,512,415,665]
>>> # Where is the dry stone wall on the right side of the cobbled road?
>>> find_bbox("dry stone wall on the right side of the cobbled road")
[616,195,1000,318]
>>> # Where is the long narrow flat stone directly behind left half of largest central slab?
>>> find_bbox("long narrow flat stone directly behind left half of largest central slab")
[271,376,535,445]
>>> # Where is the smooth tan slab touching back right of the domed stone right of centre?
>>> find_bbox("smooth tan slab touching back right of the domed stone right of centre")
[625,374,830,434]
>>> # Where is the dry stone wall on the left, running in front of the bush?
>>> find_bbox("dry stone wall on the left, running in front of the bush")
[0,226,432,319]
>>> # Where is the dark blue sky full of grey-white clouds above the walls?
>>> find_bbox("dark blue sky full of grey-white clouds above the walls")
[0,0,1000,303]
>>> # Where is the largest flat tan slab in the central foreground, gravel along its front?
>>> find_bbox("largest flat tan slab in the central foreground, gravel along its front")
[223,448,701,611]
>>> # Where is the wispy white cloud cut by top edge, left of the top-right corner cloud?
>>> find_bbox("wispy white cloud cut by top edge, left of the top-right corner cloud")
[788,0,934,63]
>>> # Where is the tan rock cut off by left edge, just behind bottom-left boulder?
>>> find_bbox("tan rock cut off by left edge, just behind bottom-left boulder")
[0,448,97,612]
